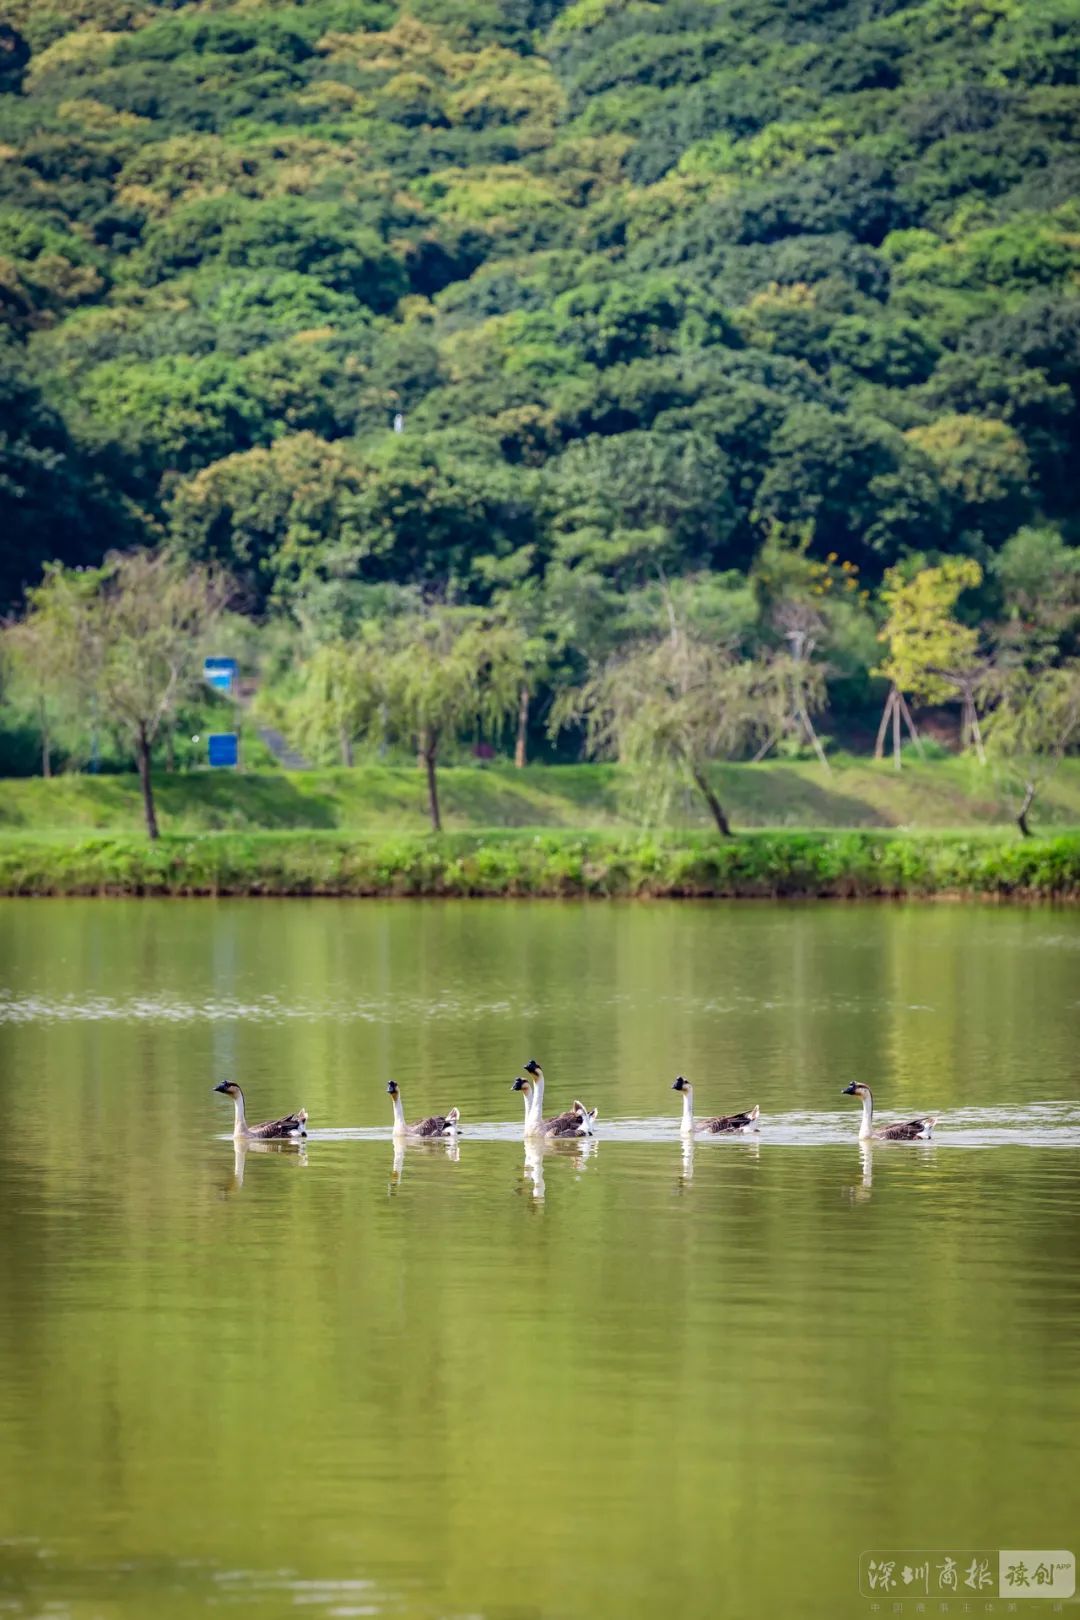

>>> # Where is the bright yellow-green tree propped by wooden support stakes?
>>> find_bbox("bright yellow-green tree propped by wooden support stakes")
[871,557,983,770]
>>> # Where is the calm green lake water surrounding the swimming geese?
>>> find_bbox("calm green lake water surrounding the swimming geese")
[0,901,1080,1620]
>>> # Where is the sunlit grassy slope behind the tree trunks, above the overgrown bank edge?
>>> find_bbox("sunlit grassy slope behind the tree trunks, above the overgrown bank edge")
[0,757,1080,834]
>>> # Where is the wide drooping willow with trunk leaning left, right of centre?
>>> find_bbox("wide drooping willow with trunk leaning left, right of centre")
[551,625,773,838]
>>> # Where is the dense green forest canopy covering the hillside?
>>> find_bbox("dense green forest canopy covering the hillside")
[0,0,1080,611]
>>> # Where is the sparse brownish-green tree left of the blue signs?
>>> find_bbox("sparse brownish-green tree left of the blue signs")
[13,551,228,838]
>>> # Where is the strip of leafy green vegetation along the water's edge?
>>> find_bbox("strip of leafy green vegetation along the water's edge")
[0,829,1080,901]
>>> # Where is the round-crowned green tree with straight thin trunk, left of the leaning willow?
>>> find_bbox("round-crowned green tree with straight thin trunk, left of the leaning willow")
[381,606,526,833]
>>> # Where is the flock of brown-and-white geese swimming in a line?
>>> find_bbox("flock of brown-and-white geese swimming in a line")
[214,1058,939,1142]
